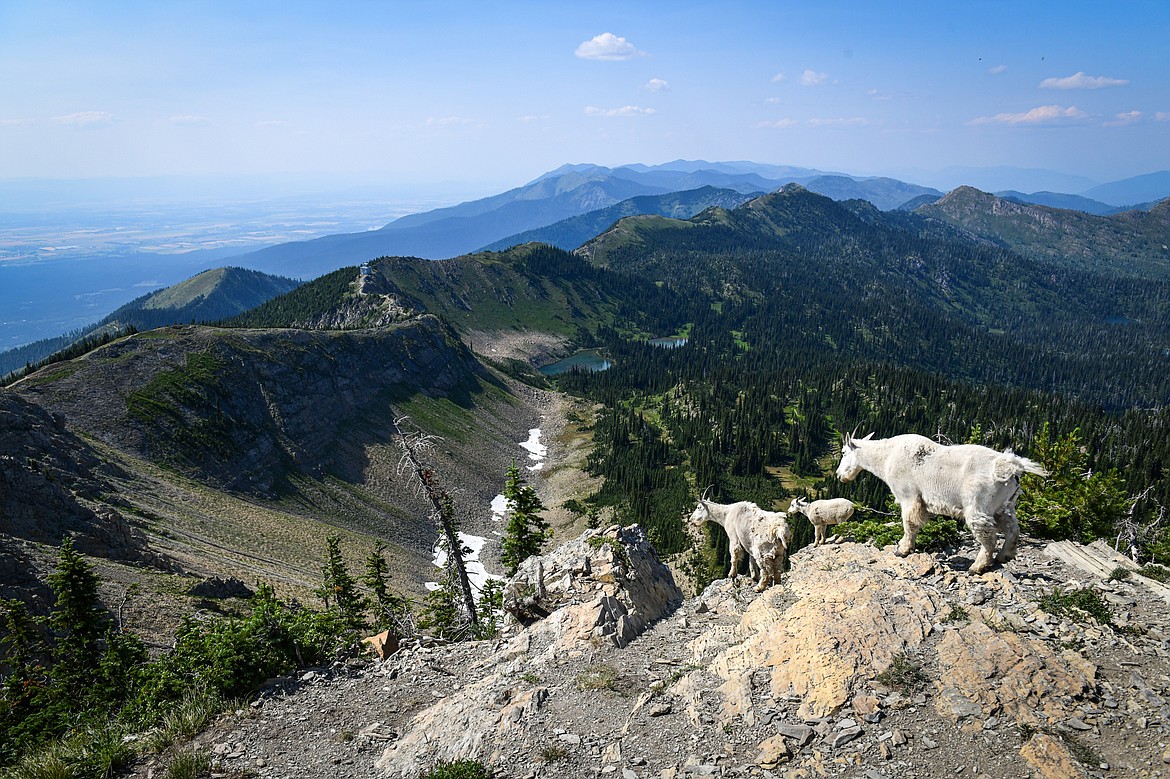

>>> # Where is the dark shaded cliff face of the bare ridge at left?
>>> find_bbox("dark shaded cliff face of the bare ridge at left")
[15,316,488,495]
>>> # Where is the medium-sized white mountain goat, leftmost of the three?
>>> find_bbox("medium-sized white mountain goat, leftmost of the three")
[690,497,792,592]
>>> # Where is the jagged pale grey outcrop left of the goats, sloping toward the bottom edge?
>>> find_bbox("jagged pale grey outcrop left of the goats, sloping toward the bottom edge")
[377,525,682,777]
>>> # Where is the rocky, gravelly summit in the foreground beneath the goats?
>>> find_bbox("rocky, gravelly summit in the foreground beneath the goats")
[137,526,1170,779]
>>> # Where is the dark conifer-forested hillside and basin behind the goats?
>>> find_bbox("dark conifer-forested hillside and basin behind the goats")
[542,188,1170,563]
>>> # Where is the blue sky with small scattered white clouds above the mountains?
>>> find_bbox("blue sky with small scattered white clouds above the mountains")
[0,0,1170,194]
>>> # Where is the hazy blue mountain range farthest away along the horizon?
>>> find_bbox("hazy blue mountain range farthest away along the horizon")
[4,160,1170,355]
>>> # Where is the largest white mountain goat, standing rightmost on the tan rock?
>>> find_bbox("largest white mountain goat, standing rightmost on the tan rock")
[837,433,1048,573]
